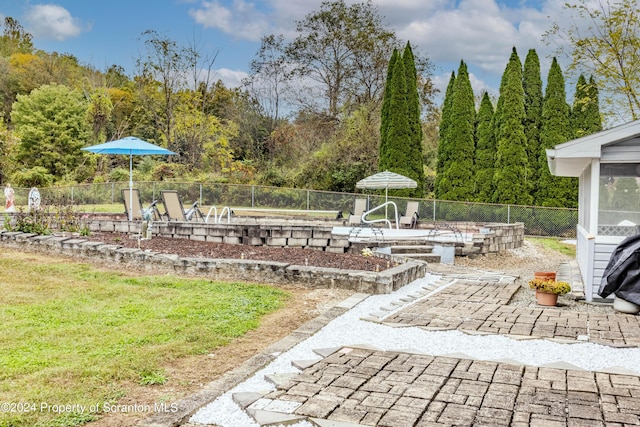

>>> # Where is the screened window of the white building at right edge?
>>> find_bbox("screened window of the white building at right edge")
[598,163,640,236]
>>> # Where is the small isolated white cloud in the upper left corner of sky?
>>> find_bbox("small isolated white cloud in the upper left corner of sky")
[26,4,82,41]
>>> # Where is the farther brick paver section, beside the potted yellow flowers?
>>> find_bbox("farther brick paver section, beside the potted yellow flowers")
[383,282,640,347]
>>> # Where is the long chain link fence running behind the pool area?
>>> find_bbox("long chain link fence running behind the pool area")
[5,182,578,238]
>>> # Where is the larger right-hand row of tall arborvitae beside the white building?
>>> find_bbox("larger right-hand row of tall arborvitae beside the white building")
[435,47,602,207]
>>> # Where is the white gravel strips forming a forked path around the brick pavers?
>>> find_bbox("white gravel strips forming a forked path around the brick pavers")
[191,274,640,427]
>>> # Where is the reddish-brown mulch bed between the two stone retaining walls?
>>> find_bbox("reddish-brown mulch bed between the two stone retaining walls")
[88,232,390,271]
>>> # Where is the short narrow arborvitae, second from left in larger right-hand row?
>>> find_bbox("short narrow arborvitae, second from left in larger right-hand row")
[475,92,496,202]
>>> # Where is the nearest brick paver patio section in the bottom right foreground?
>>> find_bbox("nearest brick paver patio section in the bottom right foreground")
[255,347,640,426]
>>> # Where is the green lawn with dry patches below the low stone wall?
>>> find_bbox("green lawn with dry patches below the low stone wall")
[0,250,288,427]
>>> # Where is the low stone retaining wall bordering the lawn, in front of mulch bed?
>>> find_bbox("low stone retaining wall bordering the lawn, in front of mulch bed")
[0,231,427,294]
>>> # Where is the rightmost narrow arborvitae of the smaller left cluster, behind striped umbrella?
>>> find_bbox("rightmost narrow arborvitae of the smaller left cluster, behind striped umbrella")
[402,42,424,197]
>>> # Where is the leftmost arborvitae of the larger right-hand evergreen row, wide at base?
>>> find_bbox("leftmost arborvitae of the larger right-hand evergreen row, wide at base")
[438,61,476,201]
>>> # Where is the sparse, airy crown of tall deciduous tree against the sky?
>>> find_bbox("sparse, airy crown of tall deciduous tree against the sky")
[286,0,398,118]
